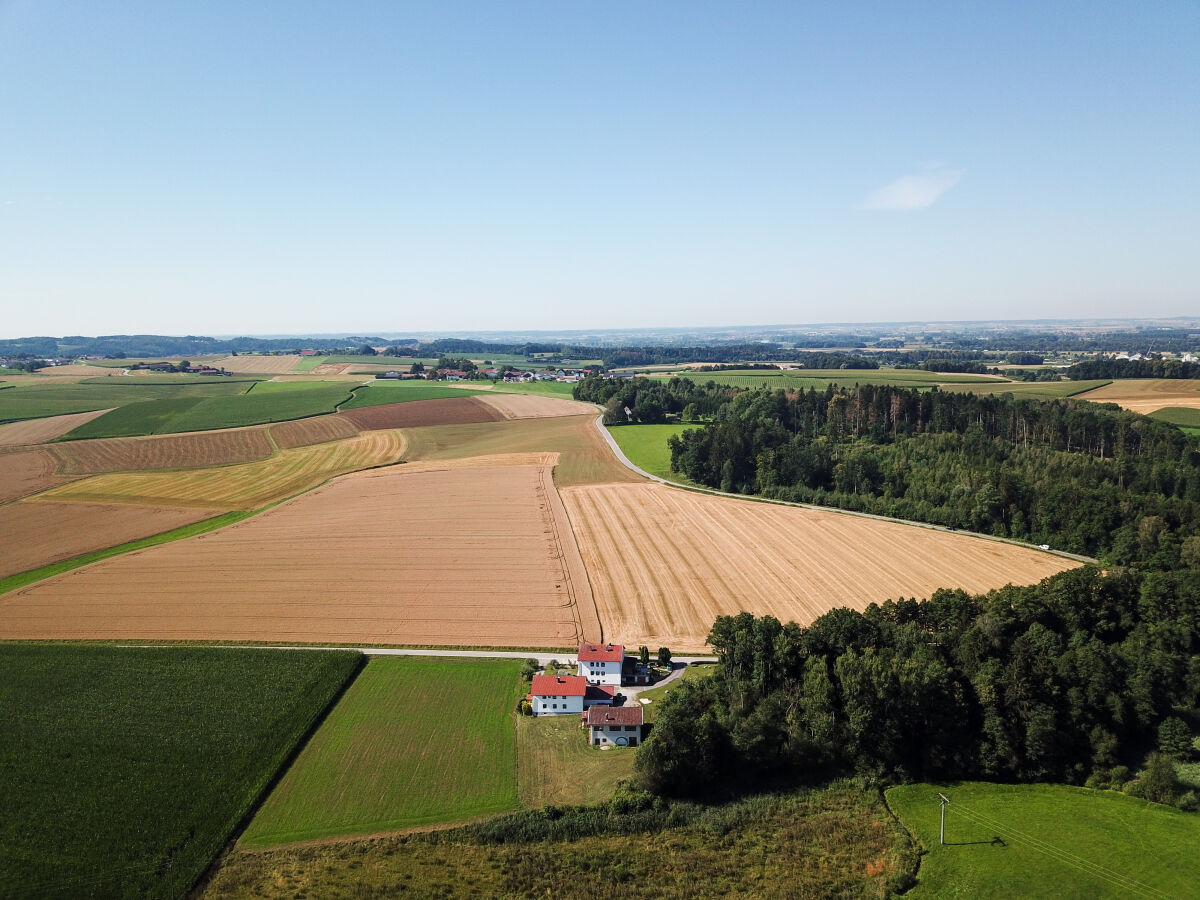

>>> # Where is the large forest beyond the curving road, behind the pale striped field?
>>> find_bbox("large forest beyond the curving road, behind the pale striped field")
[657,385,1200,569]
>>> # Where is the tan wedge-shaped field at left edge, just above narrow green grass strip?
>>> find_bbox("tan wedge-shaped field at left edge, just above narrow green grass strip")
[0,500,220,578]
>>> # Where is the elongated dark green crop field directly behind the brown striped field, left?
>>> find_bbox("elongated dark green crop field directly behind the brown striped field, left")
[62,382,350,440]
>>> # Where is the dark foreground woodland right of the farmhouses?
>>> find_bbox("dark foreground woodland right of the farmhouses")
[636,566,1200,808]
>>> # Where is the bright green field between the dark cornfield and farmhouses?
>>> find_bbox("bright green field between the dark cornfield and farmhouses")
[241,656,521,847]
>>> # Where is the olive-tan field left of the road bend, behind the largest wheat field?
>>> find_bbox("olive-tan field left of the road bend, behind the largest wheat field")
[406,413,642,486]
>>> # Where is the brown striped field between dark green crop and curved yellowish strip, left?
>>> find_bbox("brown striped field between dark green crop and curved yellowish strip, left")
[47,427,275,475]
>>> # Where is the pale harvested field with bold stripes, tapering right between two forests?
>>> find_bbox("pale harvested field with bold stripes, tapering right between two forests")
[562,484,1078,650]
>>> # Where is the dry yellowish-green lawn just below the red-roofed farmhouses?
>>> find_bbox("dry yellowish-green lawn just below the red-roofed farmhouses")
[517,715,636,809]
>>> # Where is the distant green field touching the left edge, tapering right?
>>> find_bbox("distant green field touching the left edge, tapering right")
[0,378,253,422]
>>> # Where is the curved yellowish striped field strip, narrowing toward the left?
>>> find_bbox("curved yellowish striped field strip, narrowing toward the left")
[37,431,407,510]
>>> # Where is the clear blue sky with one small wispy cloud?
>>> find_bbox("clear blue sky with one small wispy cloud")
[0,0,1200,337]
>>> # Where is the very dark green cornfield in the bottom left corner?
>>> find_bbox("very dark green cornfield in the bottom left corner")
[0,644,361,898]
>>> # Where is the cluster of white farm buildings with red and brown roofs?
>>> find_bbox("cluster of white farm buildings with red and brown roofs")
[527,643,649,746]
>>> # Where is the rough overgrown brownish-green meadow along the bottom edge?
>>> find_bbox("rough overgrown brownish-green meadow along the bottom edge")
[206,782,913,900]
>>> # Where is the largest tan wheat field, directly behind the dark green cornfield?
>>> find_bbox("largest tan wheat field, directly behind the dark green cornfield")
[0,466,600,648]
